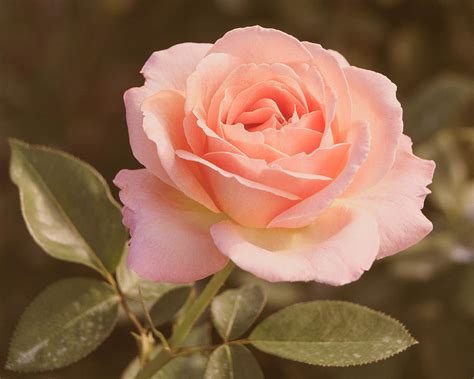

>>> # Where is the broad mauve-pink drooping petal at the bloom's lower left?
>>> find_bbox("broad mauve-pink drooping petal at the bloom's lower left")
[114,169,228,283]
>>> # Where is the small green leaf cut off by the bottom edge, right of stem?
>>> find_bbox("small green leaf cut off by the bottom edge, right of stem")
[204,344,263,379]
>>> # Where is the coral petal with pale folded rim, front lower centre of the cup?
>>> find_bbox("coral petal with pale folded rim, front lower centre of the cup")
[177,150,300,228]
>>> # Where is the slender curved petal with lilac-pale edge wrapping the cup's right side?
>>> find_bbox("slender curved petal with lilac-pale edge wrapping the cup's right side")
[268,122,370,228]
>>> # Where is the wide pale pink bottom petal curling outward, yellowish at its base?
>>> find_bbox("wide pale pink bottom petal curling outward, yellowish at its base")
[211,208,379,285]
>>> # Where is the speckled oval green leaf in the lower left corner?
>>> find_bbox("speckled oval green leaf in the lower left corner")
[6,278,119,372]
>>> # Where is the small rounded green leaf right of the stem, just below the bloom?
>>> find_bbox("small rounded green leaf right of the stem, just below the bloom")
[211,285,266,341]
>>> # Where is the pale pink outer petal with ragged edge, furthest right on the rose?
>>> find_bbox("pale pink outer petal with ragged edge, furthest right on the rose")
[344,135,435,258]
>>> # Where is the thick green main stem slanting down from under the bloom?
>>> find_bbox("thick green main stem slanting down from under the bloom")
[136,262,235,379]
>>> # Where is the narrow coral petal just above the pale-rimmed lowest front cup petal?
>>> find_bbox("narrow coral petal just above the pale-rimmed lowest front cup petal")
[203,152,331,197]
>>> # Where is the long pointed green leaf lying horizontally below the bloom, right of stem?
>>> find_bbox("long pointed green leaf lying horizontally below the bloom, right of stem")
[249,301,417,366]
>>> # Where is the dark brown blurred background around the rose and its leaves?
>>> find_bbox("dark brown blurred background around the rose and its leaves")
[0,0,474,379]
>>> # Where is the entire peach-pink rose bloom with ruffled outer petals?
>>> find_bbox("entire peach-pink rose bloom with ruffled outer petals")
[115,26,435,285]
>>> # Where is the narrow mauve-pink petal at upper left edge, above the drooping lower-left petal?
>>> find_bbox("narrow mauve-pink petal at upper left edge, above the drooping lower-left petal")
[123,87,174,185]
